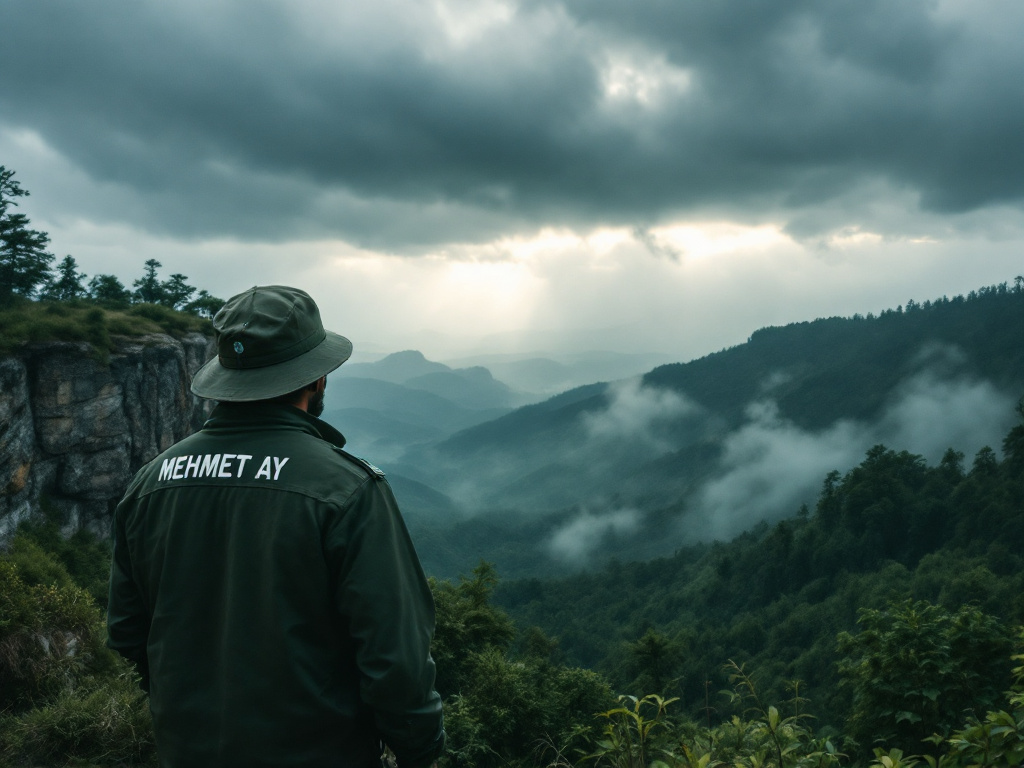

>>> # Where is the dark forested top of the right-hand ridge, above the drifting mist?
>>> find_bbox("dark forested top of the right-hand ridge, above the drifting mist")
[644,286,1024,429]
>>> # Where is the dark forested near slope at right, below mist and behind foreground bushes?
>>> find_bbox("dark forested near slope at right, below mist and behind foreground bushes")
[498,411,1024,735]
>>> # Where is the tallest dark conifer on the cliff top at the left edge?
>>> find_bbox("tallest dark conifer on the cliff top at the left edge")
[0,165,53,305]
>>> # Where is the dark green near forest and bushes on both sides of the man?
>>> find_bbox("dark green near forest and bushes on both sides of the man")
[0,409,1024,768]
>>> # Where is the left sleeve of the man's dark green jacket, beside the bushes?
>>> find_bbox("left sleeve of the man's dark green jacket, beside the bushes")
[106,502,150,692]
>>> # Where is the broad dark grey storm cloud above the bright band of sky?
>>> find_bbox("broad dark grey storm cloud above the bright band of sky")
[0,0,1024,250]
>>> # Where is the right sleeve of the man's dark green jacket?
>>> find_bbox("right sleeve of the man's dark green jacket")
[325,476,444,768]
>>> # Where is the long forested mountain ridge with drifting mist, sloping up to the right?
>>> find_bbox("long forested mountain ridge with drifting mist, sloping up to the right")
[397,283,1024,574]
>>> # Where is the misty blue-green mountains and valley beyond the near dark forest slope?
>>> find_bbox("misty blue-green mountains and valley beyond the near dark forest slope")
[326,285,1024,575]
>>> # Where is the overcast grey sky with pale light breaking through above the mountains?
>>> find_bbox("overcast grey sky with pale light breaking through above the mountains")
[0,0,1024,359]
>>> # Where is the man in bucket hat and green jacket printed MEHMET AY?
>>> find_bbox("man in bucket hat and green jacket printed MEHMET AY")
[108,286,444,768]
